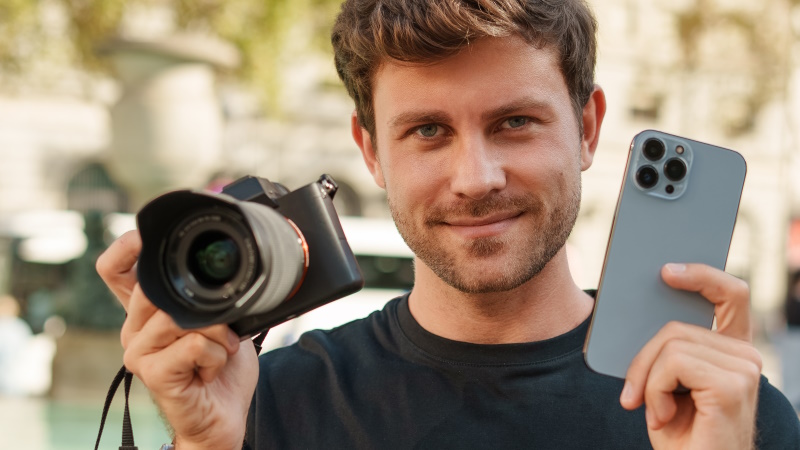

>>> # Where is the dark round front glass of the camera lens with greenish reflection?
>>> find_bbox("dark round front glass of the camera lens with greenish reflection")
[186,231,242,288]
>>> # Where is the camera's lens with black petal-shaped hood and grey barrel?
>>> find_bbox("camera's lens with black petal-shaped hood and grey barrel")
[137,191,308,328]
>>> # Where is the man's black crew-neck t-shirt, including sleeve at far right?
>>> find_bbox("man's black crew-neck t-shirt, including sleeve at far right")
[244,296,800,450]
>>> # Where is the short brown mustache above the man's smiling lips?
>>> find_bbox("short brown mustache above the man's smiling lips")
[425,193,544,226]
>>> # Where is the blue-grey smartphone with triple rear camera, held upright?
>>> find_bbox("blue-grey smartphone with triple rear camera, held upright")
[583,130,747,378]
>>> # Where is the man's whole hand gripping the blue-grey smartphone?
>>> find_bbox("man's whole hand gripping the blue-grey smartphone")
[620,264,761,450]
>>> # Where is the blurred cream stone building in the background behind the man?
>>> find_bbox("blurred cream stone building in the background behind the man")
[0,0,800,328]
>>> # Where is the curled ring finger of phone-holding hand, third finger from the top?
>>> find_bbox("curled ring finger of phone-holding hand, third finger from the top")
[644,339,760,429]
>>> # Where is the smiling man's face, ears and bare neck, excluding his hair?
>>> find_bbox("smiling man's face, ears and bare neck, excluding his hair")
[353,36,605,343]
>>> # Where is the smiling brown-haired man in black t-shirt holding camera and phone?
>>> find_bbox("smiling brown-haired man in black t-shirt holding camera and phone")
[98,0,800,449]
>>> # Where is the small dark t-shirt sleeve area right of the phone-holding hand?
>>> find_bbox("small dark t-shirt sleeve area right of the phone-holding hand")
[756,376,800,450]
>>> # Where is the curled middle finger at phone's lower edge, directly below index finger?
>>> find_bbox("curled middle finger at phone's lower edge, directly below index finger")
[620,322,761,409]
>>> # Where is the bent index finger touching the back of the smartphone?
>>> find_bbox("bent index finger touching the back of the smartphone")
[661,264,752,341]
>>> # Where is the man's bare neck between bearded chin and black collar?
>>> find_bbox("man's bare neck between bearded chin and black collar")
[408,248,593,344]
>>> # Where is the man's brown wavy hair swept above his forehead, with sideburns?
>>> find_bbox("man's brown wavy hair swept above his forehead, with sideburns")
[331,0,597,138]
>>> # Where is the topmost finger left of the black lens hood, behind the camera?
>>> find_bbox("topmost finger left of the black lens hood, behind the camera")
[95,231,142,306]
